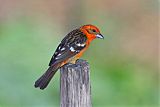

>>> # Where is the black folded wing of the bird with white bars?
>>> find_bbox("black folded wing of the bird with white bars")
[49,29,87,66]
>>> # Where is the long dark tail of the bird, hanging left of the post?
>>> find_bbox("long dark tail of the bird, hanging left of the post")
[34,64,60,90]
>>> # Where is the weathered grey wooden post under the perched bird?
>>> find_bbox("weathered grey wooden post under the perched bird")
[60,59,92,107]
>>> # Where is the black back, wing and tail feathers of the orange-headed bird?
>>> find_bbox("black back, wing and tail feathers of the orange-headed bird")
[35,29,87,90]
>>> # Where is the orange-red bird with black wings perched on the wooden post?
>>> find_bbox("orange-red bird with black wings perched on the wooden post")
[34,24,104,90]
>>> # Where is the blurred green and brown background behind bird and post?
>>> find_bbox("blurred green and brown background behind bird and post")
[0,0,160,107]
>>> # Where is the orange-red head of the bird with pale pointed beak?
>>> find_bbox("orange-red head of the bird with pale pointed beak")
[80,24,104,41]
